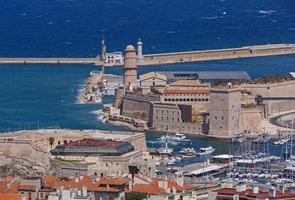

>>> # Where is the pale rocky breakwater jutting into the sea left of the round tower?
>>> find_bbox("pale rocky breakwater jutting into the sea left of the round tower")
[79,73,104,104]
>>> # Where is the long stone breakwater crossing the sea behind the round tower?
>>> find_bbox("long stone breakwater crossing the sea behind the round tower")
[0,43,295,67]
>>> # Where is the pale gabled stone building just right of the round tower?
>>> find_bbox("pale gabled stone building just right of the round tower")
[139,72,167,94]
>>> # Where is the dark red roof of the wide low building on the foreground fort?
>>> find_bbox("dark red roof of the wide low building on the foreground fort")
[64,138,125,147]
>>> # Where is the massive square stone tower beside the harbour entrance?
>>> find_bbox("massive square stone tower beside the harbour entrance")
[209,85,242,137]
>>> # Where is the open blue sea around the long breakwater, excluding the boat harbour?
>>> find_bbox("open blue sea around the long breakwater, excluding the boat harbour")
[0,0,295,138]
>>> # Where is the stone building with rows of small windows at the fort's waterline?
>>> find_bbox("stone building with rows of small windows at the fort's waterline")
[149,102,203,133]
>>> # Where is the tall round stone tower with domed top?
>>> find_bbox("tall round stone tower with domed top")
[123,45,137,91]
